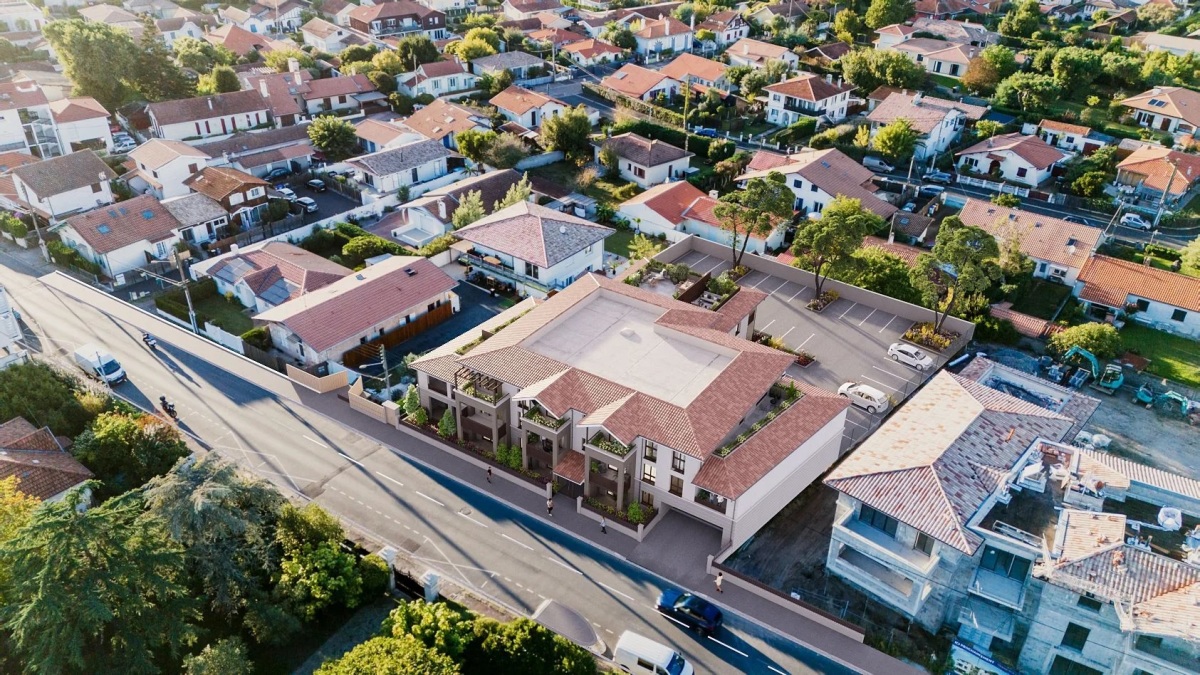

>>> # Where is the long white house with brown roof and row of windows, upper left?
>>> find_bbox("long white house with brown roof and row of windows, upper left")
[146,90,271,141]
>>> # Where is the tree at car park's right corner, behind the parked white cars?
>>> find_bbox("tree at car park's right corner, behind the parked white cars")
[908,216,1003,330]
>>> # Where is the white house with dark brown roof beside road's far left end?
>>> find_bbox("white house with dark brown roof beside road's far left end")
[12,150,116,221]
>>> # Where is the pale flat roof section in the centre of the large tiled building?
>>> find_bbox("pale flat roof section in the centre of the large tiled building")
[523,293,734,407]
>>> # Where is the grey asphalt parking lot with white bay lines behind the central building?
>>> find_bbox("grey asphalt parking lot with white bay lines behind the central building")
[676,251,946,452]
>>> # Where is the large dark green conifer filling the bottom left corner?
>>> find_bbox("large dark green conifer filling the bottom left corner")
[0,484,199,674]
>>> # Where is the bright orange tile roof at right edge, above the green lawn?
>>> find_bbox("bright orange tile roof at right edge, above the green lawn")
[1079,256,1200,312]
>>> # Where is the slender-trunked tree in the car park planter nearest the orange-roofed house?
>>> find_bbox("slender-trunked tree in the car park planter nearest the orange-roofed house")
[713,172,796,267]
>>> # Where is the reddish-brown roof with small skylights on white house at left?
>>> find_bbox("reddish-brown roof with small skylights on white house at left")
[65,195,180,253]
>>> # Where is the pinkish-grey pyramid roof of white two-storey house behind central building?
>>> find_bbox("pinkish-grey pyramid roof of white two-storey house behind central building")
[455,202,613,268]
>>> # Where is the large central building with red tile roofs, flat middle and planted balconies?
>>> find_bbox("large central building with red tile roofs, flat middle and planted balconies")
[413,267,847,548]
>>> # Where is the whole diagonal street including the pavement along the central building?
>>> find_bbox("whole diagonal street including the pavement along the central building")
[0,243,911,675]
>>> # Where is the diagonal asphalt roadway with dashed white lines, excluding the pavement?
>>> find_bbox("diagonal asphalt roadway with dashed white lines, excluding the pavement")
[0,256,868,674]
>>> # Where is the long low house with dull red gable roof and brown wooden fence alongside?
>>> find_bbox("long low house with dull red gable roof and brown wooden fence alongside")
[254,256,458,366]
